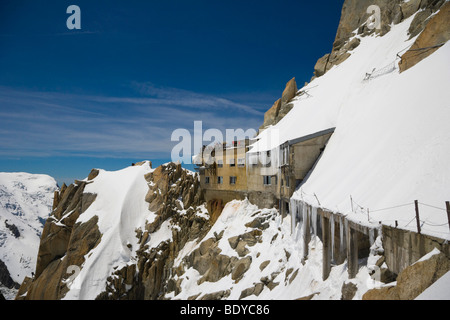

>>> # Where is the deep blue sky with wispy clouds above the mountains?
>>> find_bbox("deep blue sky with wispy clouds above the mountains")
[0,0,343,183]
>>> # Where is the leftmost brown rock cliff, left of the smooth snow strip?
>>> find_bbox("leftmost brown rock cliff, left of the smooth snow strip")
[17,178,101,300]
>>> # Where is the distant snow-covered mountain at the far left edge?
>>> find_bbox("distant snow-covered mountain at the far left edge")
[0,173,58,298]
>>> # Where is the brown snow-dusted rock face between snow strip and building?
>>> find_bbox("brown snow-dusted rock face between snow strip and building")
[97,163,207,300]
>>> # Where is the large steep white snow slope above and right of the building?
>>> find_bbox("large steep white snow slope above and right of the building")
[252,12,450,239]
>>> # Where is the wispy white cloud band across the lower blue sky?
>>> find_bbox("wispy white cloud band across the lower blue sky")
[0,83,263,159]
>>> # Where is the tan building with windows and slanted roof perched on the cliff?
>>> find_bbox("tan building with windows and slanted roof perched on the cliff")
[195,128,334,214]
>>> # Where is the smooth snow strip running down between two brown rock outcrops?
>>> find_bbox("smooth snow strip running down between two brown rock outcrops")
[65,162,155,300]
